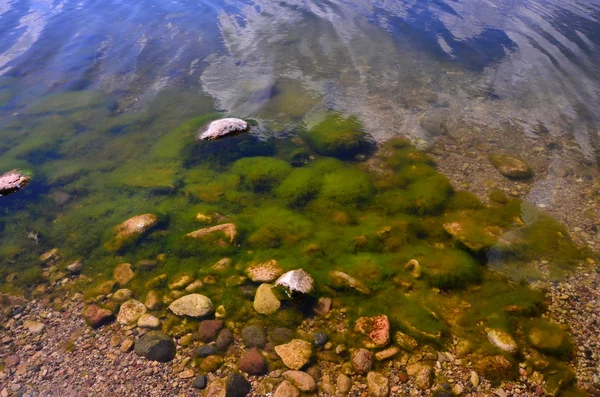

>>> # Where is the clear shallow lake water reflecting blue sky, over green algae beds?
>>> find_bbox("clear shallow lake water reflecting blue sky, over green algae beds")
[0,0,600,392]
